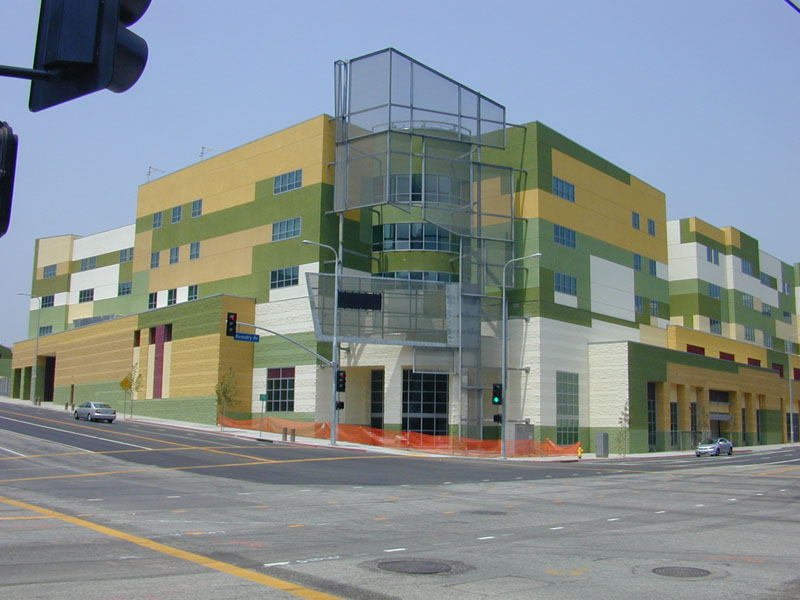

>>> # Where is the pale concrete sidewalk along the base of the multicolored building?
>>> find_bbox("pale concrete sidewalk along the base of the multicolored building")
[0,396,794,463]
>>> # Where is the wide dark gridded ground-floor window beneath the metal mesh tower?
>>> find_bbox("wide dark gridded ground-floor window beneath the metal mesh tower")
[402,369,450,435]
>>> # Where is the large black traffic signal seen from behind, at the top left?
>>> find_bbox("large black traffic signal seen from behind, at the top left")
[28,0,150,112]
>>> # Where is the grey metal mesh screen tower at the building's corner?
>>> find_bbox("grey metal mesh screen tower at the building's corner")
[326,48,514,438]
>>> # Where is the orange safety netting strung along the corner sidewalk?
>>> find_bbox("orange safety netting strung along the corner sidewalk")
[221,417,580,457]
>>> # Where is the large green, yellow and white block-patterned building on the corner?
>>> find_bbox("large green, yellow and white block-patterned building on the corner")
[11,49,800,452]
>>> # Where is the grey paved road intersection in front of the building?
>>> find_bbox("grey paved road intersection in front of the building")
[0,404,800,600]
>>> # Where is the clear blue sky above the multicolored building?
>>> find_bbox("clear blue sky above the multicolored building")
[0,0,800,345]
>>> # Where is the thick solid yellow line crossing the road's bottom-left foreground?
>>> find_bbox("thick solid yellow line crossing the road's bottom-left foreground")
[0,496,342,600]
